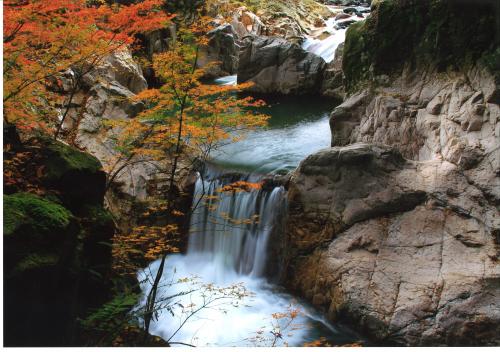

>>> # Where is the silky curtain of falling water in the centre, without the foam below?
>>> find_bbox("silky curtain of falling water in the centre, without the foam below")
[188,166,286,281]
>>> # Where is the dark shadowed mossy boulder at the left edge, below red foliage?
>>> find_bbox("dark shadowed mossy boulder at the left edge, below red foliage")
[3,142,115,347]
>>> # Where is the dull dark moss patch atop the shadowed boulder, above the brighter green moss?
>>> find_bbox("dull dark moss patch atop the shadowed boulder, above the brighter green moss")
[45,141,102,180]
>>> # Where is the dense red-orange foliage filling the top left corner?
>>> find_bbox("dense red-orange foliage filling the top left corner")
[3,0,171,129]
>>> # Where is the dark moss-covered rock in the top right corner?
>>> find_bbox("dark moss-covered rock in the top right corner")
[343,0,500,91]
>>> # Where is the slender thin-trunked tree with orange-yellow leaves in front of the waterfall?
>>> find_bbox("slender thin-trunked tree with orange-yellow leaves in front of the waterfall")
[102,18,267,339]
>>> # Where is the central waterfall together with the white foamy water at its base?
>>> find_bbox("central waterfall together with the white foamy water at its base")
[138,171,350,346]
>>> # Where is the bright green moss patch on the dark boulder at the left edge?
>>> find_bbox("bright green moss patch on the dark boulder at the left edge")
[3,193,72,236]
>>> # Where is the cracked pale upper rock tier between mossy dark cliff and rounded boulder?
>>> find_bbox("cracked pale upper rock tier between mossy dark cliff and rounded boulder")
[330,67,500,204]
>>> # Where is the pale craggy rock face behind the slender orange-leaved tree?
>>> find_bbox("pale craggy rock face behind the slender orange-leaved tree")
[59,50,195,231]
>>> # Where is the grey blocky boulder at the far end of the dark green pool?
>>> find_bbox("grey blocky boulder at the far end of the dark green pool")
[238,37,326,95]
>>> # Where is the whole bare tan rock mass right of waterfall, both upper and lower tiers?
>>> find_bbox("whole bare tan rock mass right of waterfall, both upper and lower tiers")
[286,62,500,346]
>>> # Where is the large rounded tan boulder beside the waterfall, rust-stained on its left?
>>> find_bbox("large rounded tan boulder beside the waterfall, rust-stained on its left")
[285,144,500,346]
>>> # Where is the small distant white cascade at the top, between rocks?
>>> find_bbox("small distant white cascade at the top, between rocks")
[302,7,366,63]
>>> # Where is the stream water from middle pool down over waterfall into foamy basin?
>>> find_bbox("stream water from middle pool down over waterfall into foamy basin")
[138,8,368,347]
